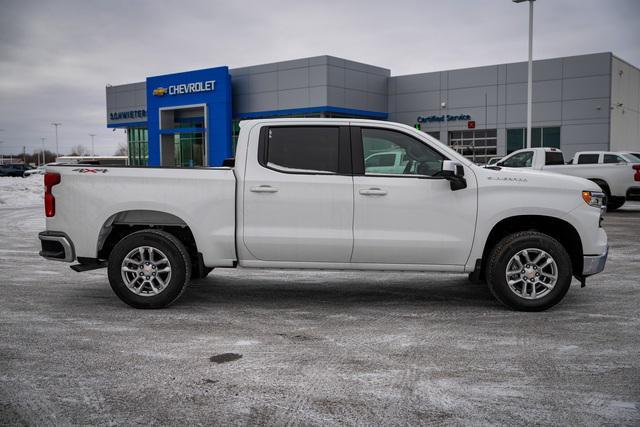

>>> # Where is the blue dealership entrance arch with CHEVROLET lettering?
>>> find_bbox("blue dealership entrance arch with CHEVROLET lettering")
[147,67,232,166]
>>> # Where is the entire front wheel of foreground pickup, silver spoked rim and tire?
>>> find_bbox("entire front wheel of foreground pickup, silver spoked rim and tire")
[487,231,573,311]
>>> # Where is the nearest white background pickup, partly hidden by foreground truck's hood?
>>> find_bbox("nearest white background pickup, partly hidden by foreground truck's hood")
[496,148,640,210]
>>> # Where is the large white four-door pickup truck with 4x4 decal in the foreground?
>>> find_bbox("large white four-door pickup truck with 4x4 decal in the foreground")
[39,119,608,311]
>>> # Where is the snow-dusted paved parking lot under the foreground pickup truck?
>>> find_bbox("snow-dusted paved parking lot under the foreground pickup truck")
[0,204,640,425]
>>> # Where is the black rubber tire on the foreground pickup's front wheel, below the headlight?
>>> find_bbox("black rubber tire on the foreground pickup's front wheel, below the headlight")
[486,231,573,311]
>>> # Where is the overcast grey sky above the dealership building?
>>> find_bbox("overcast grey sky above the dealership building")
[0,0,640,155]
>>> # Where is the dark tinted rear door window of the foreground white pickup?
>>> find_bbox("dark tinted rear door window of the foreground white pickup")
[264,126,340,174]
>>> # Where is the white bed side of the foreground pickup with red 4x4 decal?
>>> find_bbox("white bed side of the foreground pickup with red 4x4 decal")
[47,165,236,266]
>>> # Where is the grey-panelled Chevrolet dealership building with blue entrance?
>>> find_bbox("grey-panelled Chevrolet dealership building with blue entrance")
[106,52,640,167]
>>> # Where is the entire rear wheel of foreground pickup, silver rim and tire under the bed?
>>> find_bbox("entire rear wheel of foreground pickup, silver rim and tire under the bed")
[108,230,191,308]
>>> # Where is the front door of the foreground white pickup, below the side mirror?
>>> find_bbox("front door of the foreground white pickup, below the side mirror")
[351,127,477,265]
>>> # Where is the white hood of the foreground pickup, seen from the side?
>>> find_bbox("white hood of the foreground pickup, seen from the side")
[476,167,601,191]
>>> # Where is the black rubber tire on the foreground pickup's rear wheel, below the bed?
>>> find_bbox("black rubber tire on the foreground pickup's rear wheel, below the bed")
[107,230,191,308]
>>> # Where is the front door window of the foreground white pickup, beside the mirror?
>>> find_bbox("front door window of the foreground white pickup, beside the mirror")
[362,128,445,176]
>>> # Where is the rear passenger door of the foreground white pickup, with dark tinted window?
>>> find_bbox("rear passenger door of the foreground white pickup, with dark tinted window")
[243,125,353,263]
